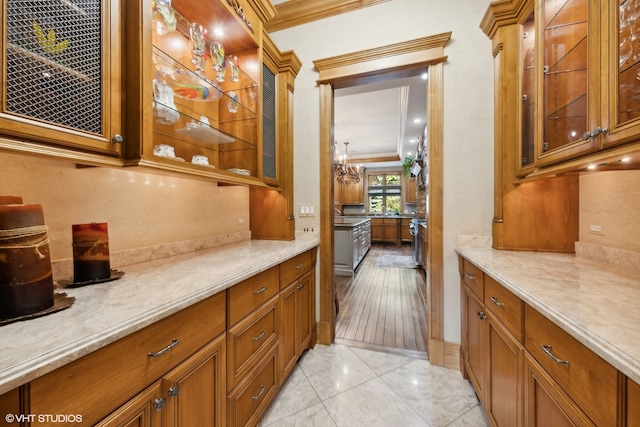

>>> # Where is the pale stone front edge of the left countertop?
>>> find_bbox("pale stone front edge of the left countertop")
[0,240,319,394]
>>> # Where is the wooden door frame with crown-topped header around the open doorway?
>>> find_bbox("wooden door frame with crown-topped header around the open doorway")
[314,33,451,366]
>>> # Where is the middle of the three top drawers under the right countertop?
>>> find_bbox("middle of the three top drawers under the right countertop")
[484,276,524,342]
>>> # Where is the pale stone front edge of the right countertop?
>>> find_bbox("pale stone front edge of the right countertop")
[456,247,640,384]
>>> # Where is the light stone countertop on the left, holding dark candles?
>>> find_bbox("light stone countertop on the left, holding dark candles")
[0,236,318,394]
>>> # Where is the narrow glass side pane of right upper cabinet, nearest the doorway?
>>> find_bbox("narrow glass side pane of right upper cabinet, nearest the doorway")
[519,12,536,175]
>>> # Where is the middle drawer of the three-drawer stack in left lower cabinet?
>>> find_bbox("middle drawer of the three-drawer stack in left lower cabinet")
[227,296,279,391]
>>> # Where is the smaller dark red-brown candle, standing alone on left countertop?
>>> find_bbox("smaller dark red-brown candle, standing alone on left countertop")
[72,222,111,283]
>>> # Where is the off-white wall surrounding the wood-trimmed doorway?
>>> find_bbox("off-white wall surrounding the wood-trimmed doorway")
[271,0,493,342]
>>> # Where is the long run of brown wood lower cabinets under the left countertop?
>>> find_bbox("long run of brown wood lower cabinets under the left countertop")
[0,248,316,427]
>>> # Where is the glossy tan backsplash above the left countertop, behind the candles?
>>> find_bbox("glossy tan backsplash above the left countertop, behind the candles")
[0,153,251,264]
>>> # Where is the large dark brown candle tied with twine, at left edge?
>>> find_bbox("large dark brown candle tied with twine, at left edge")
[0,205,53,319]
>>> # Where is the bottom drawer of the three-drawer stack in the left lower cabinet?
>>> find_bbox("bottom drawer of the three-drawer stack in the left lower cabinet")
[227,345,278,426]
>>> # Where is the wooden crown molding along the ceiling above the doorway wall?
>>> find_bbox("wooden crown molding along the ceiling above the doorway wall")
[265,0,391,33]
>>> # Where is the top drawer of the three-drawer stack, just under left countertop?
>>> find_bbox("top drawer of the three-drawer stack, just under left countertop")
[227,266,280,326]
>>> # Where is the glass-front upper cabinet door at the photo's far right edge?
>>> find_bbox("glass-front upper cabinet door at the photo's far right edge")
[603,0,640,145]
